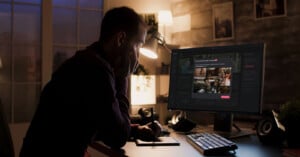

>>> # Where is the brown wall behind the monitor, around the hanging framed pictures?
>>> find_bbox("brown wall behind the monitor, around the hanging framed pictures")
[171,0,300,107]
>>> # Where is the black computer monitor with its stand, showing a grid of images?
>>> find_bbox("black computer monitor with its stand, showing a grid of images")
[168,43,265,136]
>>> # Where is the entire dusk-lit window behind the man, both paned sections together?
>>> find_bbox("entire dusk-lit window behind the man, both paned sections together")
[0,0,103,123]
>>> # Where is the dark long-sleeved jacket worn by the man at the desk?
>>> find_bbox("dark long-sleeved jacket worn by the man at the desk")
[20,43,130,157]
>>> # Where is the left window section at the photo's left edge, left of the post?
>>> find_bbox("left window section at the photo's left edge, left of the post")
[0,0,41,122]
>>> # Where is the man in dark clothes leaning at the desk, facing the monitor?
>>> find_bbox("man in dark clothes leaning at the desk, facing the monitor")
[20,7,160,157]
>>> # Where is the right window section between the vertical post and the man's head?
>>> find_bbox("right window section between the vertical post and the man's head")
[53,0,103,70]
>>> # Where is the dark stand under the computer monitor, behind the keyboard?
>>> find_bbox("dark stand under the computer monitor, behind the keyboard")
[214,113,253,139]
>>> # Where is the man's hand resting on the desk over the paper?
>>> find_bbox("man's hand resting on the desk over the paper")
[136,121,162,141]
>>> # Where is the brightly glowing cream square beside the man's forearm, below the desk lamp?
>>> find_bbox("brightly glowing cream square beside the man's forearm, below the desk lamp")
[130,75,156,105]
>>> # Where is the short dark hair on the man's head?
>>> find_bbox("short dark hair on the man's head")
[99,7,146,41]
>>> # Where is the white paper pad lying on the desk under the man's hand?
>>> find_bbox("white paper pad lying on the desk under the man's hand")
[135,136,180,146]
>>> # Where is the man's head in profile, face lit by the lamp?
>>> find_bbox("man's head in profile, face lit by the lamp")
[99,7,147,76]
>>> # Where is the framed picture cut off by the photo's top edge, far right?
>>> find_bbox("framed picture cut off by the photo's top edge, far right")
[253,0,286,19]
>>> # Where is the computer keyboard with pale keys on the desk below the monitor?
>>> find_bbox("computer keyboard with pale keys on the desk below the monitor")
[186,133,238,155]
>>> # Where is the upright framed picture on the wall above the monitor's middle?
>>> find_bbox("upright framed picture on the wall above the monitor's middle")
[212,2,234,40]
